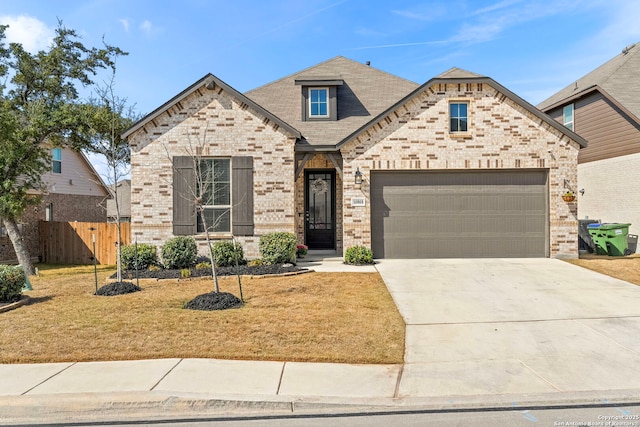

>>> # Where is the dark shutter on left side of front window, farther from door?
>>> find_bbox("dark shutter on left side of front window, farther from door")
[173,156,196,236]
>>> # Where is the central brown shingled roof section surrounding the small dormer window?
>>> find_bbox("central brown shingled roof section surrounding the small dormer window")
[245,56,418,149]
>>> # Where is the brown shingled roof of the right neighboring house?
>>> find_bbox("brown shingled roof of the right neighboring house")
[538,44,640,123]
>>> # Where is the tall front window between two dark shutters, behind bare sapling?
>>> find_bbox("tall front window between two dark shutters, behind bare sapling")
[196,159,231,233]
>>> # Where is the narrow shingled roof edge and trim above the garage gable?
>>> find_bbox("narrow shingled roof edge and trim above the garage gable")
[337,67,587,147]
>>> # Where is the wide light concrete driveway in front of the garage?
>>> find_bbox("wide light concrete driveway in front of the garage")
[377,259,640,396]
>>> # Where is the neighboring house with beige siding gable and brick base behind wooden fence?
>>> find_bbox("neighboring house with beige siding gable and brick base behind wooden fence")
[0,148,109,263]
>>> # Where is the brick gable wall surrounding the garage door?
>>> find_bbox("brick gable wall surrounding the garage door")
[341,84,579,257]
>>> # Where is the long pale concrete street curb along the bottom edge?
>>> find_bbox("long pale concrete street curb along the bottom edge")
[0,390,640,425]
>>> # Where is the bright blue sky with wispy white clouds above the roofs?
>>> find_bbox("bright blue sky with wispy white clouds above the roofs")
[0,0,640,179]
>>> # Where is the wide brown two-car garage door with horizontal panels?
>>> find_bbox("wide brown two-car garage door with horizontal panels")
[371,170,548,258]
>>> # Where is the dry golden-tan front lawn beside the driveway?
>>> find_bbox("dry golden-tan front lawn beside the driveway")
[0,266,405,363]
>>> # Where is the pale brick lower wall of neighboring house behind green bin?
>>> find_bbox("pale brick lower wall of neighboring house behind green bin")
[578,154,640,252]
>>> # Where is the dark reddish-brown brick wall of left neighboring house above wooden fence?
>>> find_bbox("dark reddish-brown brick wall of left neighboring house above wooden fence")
[0,193,107,262]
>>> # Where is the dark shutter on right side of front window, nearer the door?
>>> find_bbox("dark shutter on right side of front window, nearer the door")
[231,157,253,236]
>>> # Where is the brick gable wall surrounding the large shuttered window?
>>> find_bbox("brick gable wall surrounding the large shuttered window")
[130,82,295,258]
